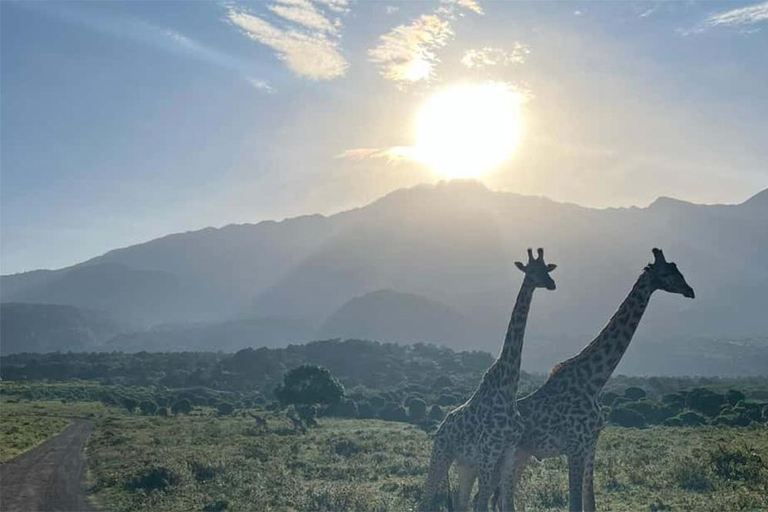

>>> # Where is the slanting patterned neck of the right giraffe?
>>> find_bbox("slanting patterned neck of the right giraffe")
[555,271,655,394]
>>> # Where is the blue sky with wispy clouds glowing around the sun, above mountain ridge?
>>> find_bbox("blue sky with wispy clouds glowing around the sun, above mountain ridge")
[0,0,768,274]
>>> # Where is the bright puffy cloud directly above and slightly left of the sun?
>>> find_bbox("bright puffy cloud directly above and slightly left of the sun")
[368,0,483,87]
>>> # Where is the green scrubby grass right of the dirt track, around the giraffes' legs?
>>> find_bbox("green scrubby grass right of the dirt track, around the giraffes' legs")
[82,412,768,511]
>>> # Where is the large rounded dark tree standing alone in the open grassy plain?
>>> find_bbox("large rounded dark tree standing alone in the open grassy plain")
[275,365,344,405]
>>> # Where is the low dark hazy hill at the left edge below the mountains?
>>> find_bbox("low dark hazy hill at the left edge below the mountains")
[0,303,125,354]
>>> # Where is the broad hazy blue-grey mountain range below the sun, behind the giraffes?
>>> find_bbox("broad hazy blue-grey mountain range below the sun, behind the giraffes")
[0,182,768,371]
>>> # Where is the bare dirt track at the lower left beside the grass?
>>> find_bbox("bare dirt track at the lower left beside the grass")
[0,420,96,512]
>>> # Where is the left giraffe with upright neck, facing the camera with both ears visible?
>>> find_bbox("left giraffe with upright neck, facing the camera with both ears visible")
[421,248,557,510]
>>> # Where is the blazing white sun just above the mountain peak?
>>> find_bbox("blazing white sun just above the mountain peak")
[413,82,523,179]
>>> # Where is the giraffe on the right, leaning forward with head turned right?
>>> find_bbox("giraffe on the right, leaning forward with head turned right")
[494,249,694,512]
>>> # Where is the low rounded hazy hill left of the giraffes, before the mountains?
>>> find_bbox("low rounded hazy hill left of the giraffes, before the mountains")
[316,290,473,347]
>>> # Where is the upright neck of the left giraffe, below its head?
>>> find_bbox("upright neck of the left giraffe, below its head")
[497,276,536,400]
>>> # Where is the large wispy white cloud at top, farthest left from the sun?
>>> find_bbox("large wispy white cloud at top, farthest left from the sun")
[227,0,349,80]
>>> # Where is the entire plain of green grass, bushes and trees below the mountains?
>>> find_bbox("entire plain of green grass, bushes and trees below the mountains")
[0,341,768,511]
